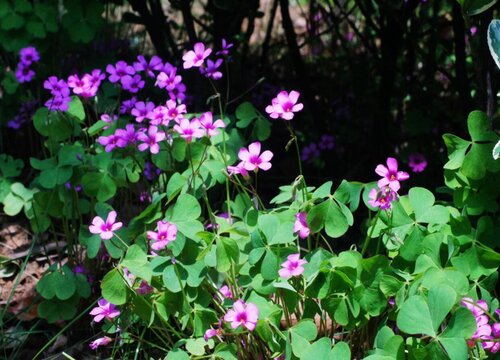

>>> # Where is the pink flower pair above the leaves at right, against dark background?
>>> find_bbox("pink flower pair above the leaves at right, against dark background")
[368,157,410,210]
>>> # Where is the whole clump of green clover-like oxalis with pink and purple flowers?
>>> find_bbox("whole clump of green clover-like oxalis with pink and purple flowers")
[1,37,500,360]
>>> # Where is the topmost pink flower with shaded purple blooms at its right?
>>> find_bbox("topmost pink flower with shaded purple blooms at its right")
[182,39,233,80]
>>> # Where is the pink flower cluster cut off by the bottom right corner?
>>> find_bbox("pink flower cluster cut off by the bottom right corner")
[461,297,500,354]
